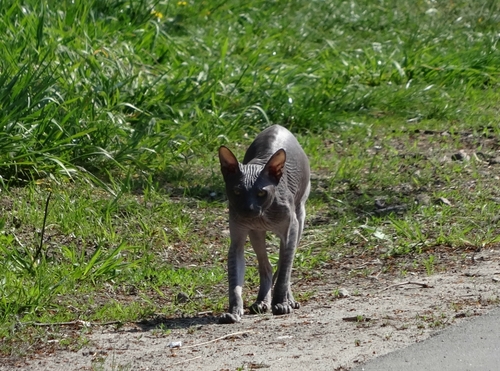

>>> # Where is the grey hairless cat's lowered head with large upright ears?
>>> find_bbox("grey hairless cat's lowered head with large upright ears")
[219,146,286,218]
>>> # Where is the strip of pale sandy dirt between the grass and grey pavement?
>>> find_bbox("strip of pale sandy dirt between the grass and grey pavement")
[4,246,500,371]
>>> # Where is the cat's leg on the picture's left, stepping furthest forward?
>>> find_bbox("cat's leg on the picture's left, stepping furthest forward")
[219,222,248,323]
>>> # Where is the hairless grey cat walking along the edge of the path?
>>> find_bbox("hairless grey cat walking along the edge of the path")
[219,125,311,323]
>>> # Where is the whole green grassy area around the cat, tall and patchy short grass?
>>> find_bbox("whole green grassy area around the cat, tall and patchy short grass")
[0,0,500,355]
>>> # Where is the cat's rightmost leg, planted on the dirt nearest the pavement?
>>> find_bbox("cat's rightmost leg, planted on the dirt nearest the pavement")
[271,215,300,315]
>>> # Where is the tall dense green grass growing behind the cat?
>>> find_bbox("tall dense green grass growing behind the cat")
[0,0,500,182]
